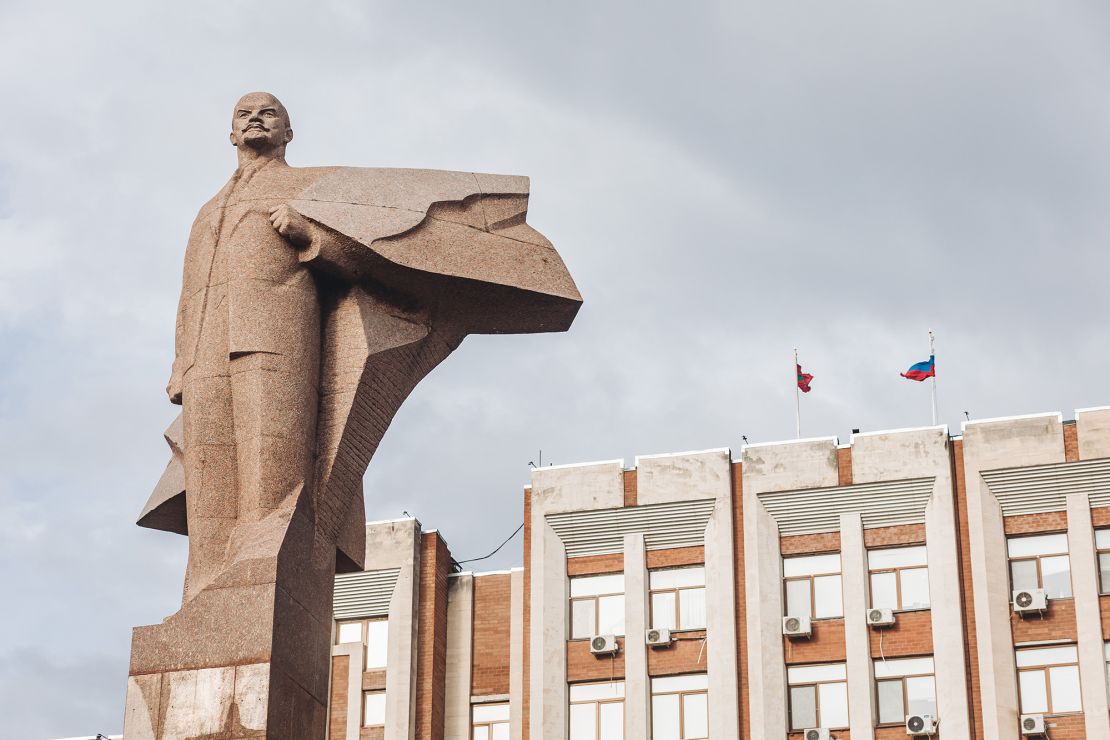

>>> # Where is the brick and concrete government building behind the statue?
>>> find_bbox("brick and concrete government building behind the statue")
[329,407,1110,740]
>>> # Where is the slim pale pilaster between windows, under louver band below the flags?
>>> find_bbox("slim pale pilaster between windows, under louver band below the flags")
[840,514,875,740]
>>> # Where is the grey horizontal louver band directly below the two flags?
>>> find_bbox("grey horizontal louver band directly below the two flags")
[758,477,936,536]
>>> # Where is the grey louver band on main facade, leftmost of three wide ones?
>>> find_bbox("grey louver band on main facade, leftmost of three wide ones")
[546,498,716,557]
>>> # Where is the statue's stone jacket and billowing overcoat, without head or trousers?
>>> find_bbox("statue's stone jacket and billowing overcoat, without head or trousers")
[148,167,582,567]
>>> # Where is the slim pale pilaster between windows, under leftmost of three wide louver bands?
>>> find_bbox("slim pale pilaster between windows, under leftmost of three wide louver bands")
[624,533,652,738]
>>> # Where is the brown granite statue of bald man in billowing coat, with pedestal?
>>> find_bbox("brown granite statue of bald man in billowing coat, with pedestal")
[124,93,581,740]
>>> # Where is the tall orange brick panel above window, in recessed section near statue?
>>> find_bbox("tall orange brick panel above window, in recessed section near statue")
[471,574,512,697]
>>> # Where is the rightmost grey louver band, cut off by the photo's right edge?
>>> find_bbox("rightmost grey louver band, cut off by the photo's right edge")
[981,457,1110,516]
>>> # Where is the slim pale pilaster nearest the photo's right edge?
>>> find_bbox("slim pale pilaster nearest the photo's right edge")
[1067,494,1110,738]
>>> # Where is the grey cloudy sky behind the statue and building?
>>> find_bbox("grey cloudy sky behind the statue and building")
[0,0,1110,740]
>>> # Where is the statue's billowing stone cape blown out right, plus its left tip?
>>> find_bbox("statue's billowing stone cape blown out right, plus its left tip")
[138,168,582,570]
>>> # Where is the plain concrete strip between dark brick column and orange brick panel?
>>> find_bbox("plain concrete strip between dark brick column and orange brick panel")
[444,574,474,738]
